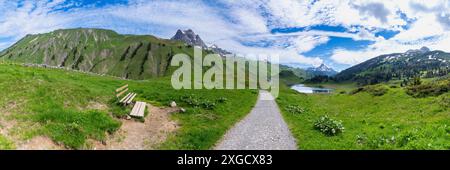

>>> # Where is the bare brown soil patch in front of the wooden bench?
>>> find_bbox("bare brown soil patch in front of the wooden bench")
[93,104,179,150]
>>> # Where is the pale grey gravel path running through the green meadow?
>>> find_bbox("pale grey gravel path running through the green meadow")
[215,91,297,150]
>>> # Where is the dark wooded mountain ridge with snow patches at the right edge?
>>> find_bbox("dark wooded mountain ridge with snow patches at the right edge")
[335,47,450,84]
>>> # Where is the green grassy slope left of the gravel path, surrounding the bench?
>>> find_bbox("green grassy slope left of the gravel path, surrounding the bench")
[0,64,257,149]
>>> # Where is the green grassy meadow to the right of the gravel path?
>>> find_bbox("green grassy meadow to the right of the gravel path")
[277,85,450,149]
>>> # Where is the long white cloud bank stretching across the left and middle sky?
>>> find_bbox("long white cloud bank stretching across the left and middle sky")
[0,1,328,64]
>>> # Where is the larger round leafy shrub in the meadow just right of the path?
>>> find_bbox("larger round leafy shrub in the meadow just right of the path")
[314,115,345,136]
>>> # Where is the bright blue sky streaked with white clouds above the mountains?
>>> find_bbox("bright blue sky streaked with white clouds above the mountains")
[0,0,450,70]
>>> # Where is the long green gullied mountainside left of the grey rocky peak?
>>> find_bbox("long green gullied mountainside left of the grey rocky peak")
[0,28,200,79]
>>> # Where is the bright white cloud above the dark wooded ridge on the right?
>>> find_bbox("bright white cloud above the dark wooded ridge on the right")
[331,1,450,65]
